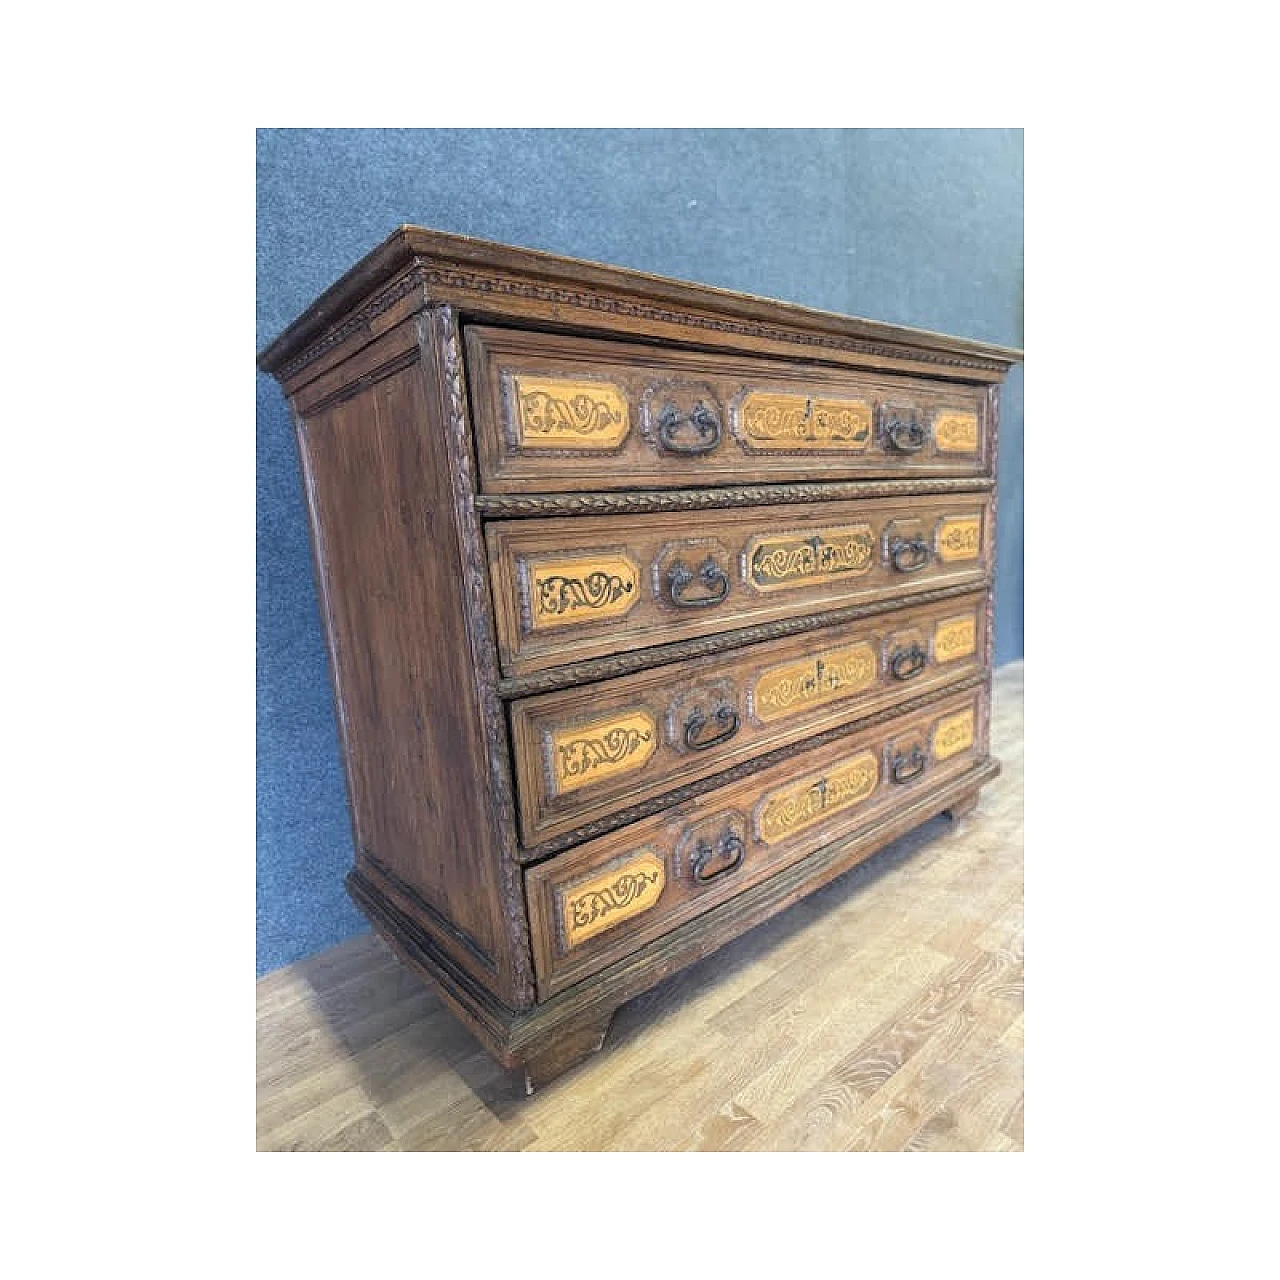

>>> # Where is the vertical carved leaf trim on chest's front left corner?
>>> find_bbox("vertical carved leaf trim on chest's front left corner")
[432,307,535,1002]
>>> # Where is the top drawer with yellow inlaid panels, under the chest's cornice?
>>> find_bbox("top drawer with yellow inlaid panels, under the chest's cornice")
[466,326,991,493]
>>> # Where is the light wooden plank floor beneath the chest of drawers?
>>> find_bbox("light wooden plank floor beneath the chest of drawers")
[257,662,1023,1151]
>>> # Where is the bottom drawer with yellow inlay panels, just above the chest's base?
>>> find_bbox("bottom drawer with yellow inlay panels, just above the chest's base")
[525,689,988,997]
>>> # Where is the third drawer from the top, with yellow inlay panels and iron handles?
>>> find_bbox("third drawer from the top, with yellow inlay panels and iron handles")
[511,591,987,846]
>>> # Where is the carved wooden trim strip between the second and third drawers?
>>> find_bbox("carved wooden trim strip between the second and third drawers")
[498,577,991,698]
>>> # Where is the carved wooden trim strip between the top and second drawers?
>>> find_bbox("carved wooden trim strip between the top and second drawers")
[475,476,996,520]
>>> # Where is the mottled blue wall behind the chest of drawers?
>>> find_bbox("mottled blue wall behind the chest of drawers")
[257,129,1023,974]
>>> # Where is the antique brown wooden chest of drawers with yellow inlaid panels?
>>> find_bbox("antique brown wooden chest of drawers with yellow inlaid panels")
[259,227,1020,1088]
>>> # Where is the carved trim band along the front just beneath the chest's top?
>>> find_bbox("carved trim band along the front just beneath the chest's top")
[426,264,1009,372]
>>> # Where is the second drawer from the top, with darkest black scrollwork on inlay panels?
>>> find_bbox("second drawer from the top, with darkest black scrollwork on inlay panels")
[485,494,992,676]
